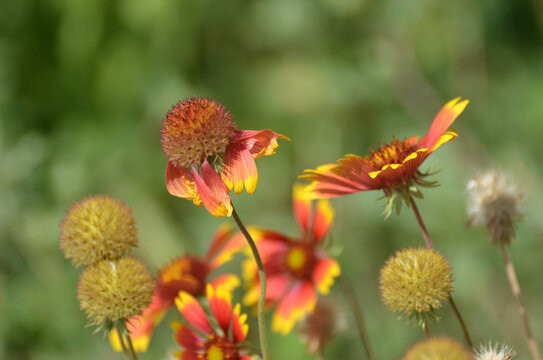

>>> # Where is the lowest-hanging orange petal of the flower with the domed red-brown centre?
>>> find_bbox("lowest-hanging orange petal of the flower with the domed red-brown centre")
[192,160,232,217]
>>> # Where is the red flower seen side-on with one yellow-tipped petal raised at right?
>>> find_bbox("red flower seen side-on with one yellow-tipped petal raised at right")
[301,98,468,199]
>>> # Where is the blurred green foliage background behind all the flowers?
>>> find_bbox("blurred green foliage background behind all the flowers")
[0,0,543,360]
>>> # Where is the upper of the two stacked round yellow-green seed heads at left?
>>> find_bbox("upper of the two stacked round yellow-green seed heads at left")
[60,195,138,266]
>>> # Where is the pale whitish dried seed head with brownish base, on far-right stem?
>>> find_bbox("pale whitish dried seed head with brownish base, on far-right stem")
[467,171,522,245]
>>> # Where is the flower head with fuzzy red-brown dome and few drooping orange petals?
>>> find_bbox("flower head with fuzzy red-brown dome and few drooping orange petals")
[161,97,288,217]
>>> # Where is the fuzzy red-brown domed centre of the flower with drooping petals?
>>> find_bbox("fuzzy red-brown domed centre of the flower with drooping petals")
[161,98,236,167]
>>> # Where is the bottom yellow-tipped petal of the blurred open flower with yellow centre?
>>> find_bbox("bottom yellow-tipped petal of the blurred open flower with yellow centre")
[272,281,317,336]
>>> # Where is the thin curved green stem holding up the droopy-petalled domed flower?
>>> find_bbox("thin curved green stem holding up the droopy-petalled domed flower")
[232,204,270,360]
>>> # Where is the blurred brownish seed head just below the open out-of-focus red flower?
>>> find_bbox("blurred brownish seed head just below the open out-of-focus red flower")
[299,297,345,354]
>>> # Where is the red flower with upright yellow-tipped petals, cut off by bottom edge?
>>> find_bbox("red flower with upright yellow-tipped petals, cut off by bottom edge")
[172,285,254,360]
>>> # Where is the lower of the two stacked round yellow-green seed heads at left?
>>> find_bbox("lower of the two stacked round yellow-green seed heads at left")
[77,257,154,327]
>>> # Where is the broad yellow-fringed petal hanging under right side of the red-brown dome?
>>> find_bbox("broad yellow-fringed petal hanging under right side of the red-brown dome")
[222,142,258,194]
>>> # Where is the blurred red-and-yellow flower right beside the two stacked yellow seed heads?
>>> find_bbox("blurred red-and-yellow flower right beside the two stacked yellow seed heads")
[110,224,239,352]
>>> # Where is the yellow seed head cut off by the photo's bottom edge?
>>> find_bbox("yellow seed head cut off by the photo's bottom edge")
[402,337,472,360]
